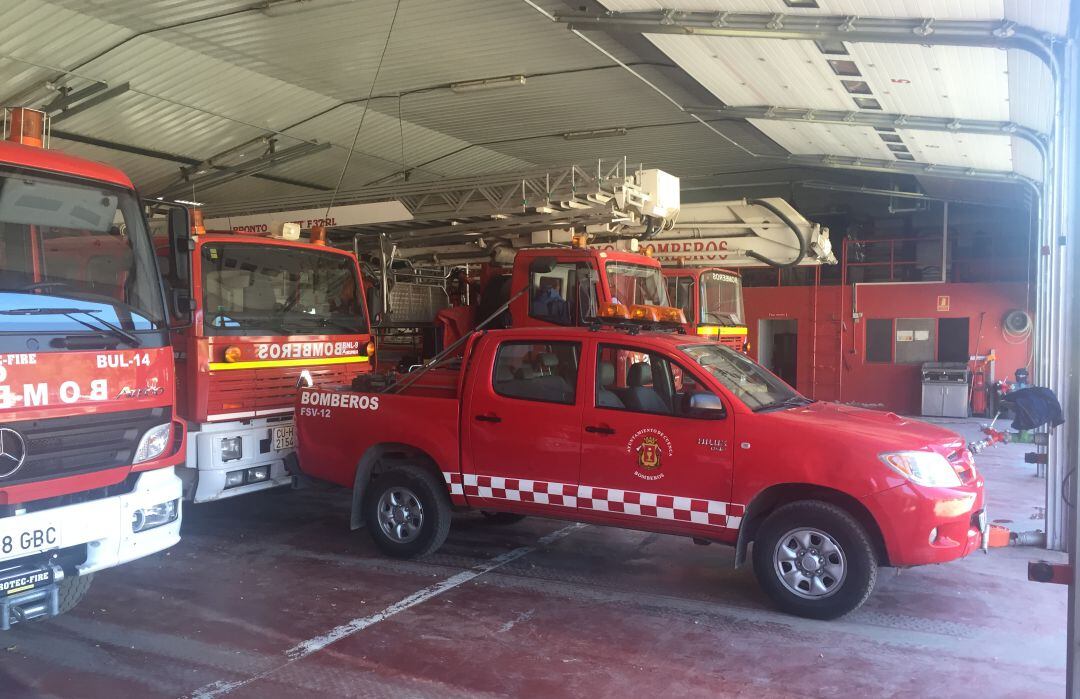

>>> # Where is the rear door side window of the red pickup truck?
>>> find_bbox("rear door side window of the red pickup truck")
[491,341,581,405]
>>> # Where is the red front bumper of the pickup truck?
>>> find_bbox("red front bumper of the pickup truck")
[863,475,988,567]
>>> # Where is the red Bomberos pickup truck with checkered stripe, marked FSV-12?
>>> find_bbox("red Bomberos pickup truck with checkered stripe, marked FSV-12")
[296,326,986,619]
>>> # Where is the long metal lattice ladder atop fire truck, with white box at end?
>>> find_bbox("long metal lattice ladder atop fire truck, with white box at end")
[206,159,678,258]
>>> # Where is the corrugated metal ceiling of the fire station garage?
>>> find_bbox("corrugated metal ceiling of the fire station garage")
[0,0,1067,206]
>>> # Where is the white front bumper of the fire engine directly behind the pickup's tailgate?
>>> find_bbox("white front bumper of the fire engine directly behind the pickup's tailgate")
[178,415,295,502]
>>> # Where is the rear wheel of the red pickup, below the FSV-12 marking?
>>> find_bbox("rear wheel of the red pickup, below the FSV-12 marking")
[364,466,450,559]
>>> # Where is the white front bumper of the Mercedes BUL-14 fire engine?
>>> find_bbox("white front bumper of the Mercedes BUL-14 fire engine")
[0,467,181,630]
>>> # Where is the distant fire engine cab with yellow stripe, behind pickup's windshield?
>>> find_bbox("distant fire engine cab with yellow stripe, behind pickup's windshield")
[664,267,748,352]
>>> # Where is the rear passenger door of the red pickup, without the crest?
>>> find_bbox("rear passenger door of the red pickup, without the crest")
[461,338,581,516]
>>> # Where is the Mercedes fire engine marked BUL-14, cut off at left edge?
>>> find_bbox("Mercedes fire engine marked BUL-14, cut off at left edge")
[0,109,188,630]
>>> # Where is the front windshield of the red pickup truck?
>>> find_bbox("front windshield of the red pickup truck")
[679,344,812,413]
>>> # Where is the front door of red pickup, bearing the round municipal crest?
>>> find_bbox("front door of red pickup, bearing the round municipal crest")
[578,337,742,540]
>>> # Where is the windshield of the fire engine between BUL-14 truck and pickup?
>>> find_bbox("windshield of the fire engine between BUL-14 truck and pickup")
[200,243,367,335]
